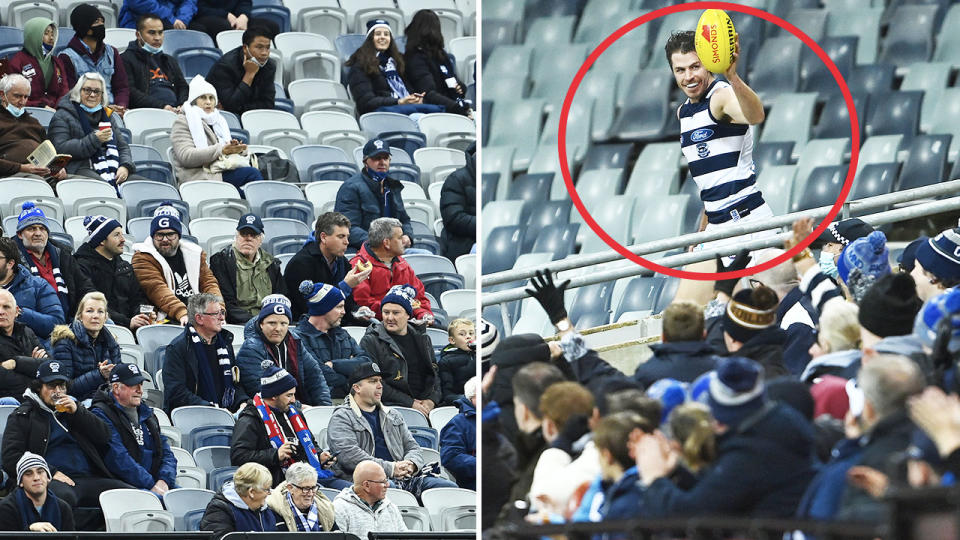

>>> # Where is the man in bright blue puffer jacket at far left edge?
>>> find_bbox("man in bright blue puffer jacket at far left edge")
[0,237,63,345]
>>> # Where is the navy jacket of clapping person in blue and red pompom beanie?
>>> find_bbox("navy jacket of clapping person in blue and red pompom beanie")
[639,403,816,518]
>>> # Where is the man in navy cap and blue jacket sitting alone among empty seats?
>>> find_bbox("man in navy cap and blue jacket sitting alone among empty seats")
[334,139,413,250]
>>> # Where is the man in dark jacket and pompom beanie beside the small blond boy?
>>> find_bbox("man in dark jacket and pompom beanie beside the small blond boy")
[360,285,440,416]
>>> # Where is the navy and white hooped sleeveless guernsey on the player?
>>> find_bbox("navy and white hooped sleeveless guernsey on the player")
[677,79,763,224]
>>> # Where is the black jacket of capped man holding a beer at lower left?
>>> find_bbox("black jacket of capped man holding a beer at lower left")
[0,389,114,478]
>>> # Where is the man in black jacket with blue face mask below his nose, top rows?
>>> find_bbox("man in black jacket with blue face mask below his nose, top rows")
[120,14,191,112]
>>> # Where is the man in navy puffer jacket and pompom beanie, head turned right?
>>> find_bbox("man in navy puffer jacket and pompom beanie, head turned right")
[297,280,370,398]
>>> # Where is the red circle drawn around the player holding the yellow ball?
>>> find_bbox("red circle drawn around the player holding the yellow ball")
[557,2,860,281]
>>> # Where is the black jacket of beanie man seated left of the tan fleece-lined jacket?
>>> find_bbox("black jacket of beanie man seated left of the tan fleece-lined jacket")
[73,242,147,328]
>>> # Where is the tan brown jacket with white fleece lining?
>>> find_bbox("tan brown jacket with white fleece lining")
[133,238,223,321]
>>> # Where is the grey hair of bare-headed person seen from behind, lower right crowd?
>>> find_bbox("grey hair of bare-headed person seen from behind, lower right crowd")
[857,354,927,419]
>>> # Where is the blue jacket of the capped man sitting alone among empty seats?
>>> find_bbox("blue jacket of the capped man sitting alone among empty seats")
[333,168,413,249]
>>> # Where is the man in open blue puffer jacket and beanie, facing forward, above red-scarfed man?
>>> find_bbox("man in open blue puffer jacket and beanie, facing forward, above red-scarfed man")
[237,297,333,406]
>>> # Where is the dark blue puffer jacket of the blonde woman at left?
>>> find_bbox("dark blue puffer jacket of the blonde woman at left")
[51,319,120,400]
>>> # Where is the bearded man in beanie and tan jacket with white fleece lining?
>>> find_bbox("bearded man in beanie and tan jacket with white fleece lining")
[133,212,222,325]
